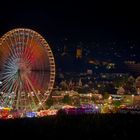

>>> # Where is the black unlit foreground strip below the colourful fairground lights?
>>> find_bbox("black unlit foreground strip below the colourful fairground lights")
[0,114,140,140]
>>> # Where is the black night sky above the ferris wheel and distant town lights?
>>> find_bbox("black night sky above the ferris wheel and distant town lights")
[0,0,140,41]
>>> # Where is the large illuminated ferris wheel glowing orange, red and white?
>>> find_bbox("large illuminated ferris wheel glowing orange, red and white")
[0,28,55,111]
